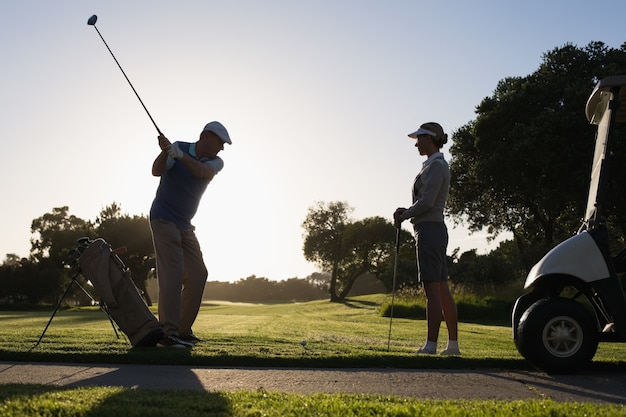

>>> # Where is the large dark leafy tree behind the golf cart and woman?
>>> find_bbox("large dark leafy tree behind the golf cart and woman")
[448,42,626,270]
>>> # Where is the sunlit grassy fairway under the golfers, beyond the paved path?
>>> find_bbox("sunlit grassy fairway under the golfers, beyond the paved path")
[0,295,626,369]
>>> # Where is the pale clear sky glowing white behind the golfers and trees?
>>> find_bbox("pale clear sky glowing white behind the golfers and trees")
[0,0,626,281]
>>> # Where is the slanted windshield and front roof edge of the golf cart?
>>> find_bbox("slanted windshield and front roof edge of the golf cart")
[585,75,626,227]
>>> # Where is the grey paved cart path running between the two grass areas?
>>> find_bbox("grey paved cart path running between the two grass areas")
[0,361,626,404]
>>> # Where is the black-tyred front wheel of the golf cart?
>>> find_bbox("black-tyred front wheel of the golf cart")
[517,298,598,373]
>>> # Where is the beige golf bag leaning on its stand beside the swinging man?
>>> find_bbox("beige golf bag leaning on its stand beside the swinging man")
[77,238,163,347]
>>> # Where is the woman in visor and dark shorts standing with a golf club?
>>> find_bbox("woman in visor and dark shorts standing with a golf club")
[393,122,461,356]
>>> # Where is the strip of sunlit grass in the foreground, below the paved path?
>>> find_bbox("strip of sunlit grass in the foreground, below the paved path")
[0,385,626,417]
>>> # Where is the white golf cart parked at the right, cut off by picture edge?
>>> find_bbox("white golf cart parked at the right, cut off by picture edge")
[512,75,626,373]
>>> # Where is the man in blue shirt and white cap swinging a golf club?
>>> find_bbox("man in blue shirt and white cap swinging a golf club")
[150,122,232,348]
